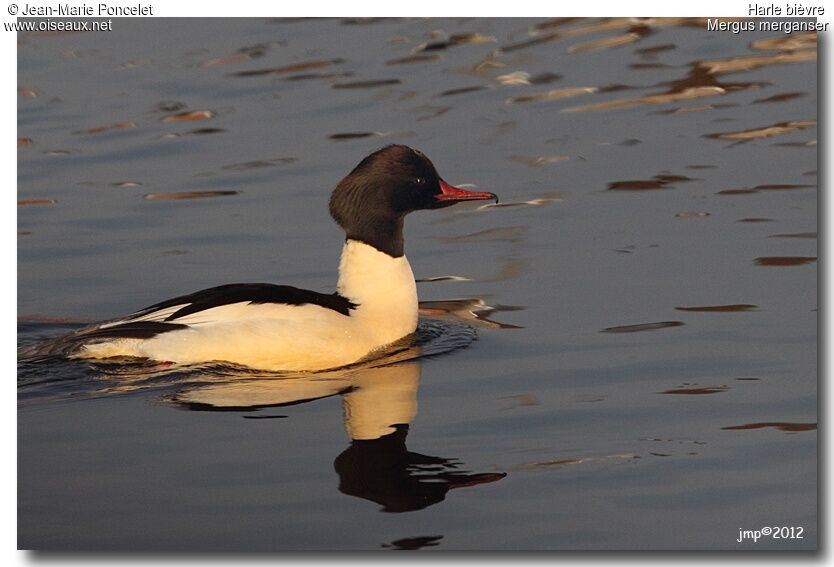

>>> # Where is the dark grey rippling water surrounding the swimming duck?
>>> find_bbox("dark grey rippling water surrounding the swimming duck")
[18,19,818,551]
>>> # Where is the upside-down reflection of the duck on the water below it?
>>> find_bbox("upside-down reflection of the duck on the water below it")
[174,336,506,512]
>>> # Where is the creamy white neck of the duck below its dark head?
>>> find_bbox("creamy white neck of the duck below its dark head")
[336,240,417,346]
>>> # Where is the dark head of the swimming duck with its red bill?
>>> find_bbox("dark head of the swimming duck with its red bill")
[330,145,498,257]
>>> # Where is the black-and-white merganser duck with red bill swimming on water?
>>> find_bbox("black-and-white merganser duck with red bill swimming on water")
[25,144,498,371]
